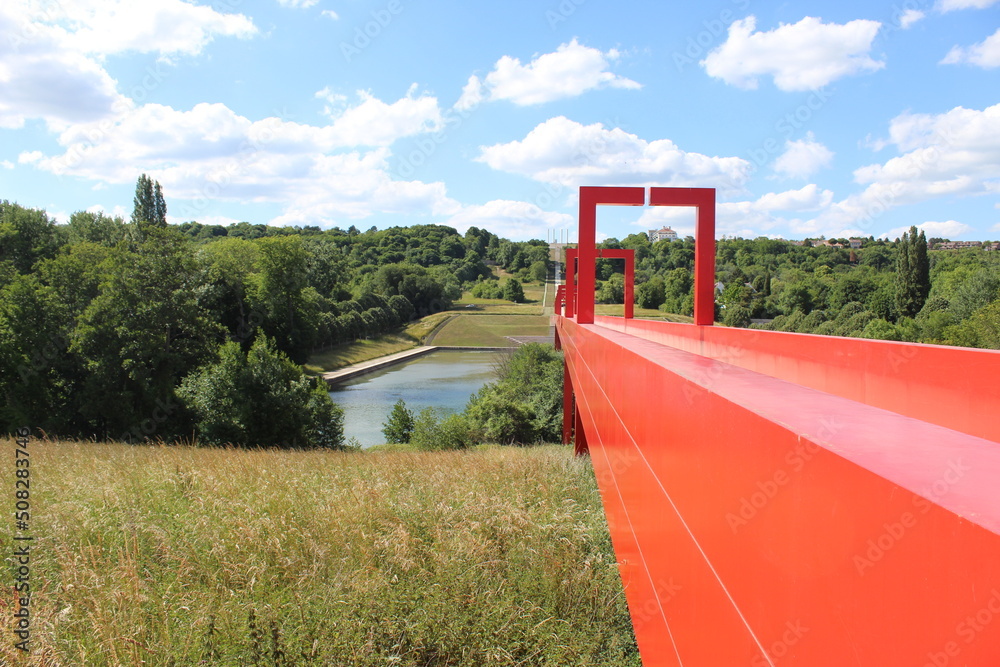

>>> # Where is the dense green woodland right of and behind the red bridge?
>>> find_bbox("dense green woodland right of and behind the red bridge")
[597,228,1000,349]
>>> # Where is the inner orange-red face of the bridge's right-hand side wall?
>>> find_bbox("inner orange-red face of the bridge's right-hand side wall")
[597,317,1000,448]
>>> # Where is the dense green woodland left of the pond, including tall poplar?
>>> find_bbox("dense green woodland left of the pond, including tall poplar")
[0,177,548,447]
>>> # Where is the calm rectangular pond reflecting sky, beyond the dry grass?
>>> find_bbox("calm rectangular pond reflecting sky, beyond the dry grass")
[330,350,497,447]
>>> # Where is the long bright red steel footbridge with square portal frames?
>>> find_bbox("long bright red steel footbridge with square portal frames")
[555,187,1000,667]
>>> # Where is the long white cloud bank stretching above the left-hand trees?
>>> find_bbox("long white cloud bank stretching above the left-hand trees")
[19,88,459,225]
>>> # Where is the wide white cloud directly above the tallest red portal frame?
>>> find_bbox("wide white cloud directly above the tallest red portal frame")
[477,116,751,192]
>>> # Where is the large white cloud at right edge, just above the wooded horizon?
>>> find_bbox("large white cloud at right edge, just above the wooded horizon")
[815,104,1000,231]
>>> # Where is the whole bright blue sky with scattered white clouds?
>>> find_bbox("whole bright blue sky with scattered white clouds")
[0,0,1000,240]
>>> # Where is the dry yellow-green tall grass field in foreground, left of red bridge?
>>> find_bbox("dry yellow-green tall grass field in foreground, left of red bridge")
[0,440,640,667]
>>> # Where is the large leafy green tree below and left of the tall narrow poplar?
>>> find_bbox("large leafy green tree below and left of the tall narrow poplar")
[70,227,222,438]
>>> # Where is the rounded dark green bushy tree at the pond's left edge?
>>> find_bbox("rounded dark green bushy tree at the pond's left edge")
[177,336,344,449]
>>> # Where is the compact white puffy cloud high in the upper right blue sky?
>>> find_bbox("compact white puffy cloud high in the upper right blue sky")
[701,16,885,91]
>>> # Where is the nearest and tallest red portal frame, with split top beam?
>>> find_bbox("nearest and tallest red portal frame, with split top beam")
[566,186,715,326]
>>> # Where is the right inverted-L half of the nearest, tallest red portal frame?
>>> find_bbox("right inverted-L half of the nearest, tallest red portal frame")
[648,188,715,326]
